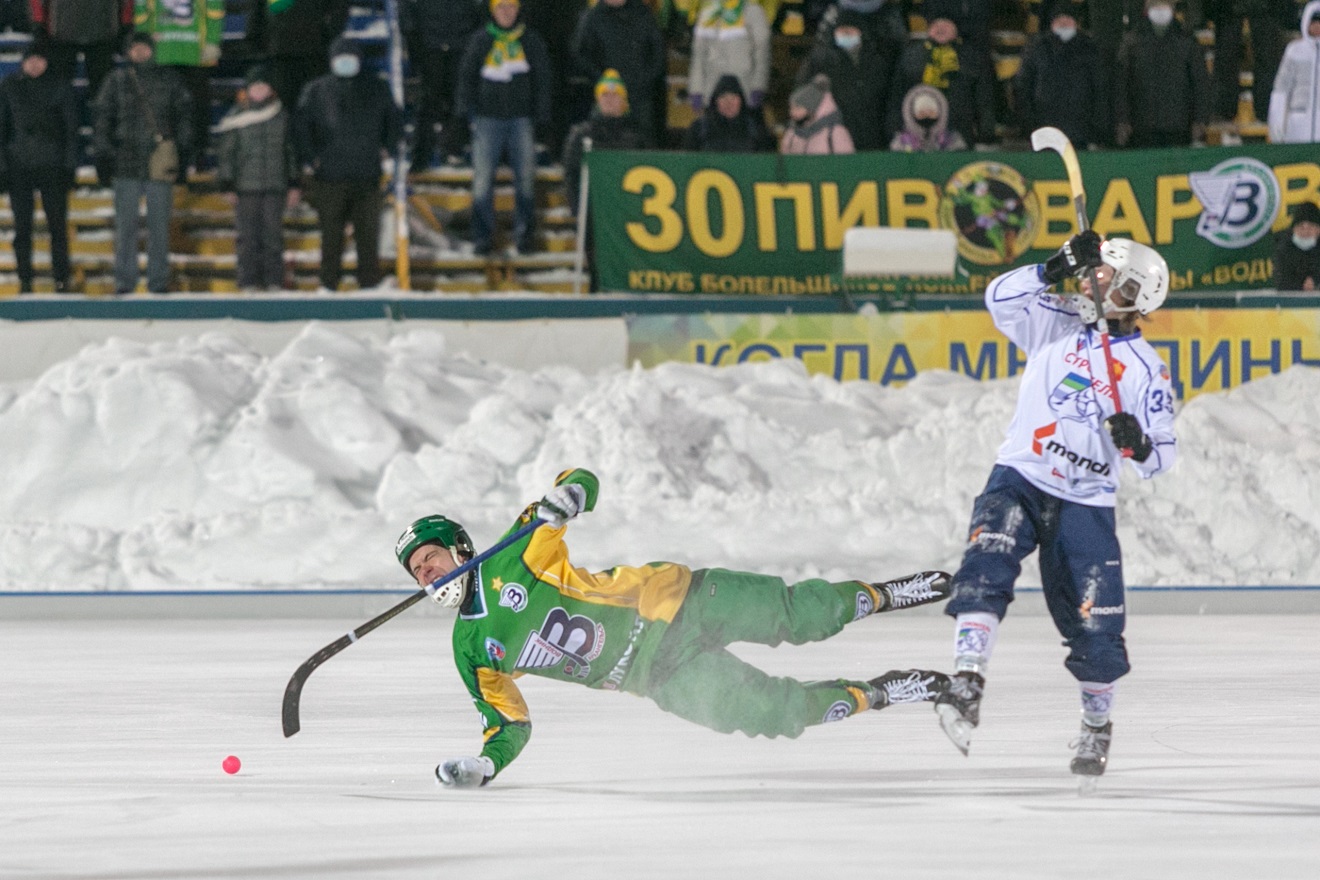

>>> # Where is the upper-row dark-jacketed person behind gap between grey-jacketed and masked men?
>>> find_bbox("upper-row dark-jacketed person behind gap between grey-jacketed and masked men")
[248,0,348,107]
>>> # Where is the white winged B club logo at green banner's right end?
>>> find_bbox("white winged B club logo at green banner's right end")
[1187,156,1280,248]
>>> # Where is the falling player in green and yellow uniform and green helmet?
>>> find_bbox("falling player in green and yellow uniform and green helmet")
[395,468,949,788]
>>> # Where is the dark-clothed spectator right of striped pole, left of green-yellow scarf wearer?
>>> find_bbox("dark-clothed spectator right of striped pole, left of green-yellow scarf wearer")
[399,0,484,169]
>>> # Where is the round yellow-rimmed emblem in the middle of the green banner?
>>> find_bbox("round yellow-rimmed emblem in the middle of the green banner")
[940,162,1040,265]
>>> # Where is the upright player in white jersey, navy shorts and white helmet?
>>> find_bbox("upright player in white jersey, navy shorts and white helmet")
[936,231,1176,776]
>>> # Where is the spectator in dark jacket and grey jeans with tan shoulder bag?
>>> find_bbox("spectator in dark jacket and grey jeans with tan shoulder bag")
[92,33,193,293]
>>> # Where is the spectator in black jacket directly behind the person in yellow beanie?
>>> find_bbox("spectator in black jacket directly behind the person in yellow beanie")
[573,0,668,142]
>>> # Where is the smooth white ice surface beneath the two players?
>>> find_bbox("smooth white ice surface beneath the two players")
[0,613,1320,880]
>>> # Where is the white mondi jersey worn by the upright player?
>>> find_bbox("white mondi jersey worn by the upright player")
[986,265,1177,507]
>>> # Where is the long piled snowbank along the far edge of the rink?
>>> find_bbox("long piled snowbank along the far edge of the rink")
[0,323,1320,591]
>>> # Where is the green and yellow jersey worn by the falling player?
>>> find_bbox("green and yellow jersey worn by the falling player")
[453,468,692,773]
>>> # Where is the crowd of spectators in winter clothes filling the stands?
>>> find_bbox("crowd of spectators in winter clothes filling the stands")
[0,0,1320,292]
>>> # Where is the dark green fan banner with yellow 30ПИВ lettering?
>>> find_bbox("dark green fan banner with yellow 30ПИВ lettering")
[587,144,1320,294]
